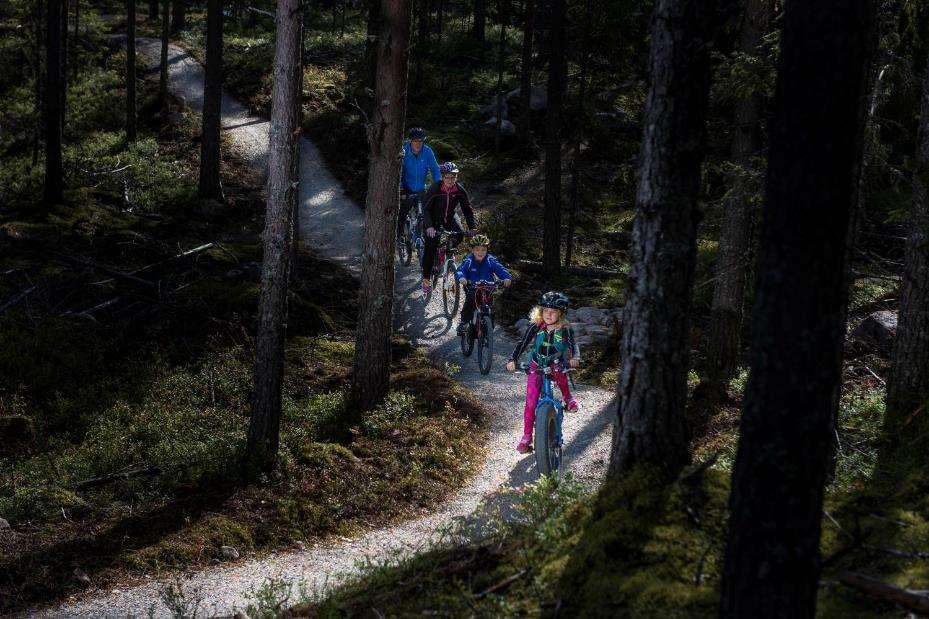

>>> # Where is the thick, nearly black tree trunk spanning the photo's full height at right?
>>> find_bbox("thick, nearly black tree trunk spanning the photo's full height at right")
[721,0,876,617]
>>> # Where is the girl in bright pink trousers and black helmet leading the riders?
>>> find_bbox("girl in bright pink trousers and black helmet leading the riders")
[506,291,581,453]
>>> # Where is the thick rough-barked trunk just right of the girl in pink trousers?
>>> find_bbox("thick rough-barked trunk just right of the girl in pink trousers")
[610,0,733,478]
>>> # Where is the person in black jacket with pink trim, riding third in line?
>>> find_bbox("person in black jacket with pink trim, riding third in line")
[423,161,475,293]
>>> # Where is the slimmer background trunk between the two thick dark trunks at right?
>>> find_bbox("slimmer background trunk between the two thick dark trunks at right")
[706,0,773,392]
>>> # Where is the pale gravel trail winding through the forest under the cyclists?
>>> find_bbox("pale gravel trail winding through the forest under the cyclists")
[36,38,614,617]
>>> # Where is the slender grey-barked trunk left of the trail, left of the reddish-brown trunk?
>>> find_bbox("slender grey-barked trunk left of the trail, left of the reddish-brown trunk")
[246,0,302,472]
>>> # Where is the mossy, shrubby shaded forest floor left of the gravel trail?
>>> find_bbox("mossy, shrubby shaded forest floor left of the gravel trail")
[0,16,484,613]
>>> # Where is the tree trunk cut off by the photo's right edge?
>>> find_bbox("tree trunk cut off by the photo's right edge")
[885,57,929,438]
